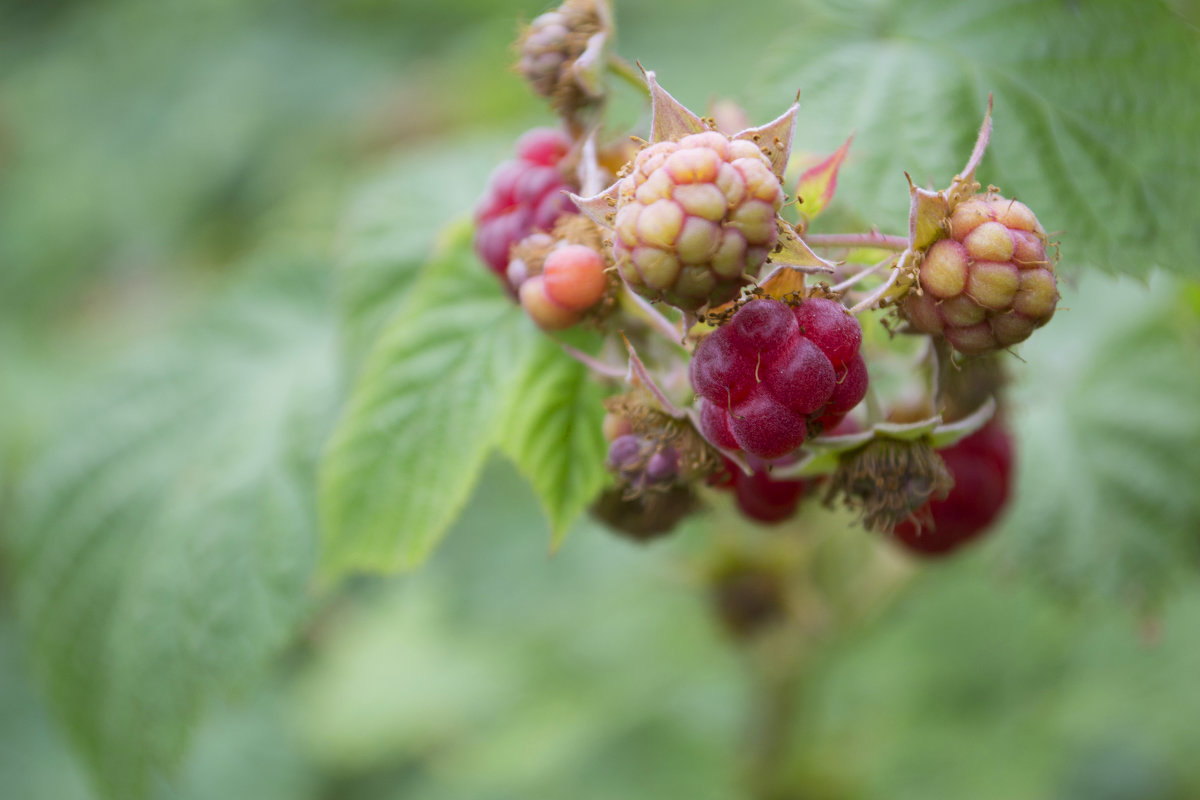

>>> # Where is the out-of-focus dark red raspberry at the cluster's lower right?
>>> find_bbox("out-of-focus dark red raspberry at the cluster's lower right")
[895,420,1013,557]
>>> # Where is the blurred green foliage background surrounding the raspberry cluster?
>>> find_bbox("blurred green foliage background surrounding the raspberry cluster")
[0,0,1200,800]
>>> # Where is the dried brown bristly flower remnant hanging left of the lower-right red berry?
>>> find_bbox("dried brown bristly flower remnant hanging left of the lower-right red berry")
[824,438,954,533]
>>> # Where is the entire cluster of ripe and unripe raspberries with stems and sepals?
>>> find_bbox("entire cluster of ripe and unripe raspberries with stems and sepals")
[475,0,1058,563]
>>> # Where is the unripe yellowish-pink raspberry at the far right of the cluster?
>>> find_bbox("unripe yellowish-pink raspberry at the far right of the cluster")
[902,194,1058,355]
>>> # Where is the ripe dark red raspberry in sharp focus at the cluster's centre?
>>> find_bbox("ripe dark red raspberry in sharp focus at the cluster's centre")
[691,297,866,459]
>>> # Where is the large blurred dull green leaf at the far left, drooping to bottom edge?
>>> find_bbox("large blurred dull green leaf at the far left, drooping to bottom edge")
[5,270,335,800]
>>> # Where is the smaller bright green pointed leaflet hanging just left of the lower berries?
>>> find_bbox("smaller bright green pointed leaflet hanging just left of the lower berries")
[500,338,607,548]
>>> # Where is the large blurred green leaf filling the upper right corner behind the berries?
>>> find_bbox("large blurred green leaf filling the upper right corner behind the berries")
[761,0,1200,277]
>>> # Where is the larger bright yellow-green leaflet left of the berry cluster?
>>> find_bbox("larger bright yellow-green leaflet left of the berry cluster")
[320,227,534,573]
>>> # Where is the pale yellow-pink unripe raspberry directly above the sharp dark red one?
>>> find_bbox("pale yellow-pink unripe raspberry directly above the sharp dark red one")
[613,131,784,311]
